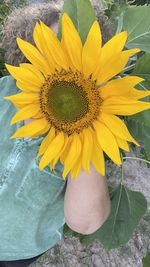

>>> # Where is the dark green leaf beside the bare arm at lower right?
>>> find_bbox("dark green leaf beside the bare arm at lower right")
[80,184,147,249]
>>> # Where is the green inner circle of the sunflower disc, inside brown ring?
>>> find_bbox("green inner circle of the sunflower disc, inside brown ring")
[48,81,88,122]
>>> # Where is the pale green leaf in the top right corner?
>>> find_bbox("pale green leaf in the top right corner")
[123,6,150,53]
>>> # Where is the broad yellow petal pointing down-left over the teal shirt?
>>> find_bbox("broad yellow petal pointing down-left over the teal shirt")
[39,132,64,170]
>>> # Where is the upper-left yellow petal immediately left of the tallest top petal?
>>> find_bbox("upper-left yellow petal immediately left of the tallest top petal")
[41,22,68,70]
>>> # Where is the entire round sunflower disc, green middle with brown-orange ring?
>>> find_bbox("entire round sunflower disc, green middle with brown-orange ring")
[40,70,102,135]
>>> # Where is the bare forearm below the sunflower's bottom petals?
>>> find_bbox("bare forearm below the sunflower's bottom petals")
[64,165,110,234]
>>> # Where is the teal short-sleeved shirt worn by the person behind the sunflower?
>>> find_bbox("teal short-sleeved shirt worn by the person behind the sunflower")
[0,76,66,260]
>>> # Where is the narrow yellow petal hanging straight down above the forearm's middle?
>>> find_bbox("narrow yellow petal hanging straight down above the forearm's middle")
[82,128,93,174]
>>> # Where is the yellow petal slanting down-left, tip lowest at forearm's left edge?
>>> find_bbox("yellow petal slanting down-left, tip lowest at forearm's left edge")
[62,133,81,178]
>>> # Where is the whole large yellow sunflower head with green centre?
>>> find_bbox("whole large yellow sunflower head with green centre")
[5,13,150,178]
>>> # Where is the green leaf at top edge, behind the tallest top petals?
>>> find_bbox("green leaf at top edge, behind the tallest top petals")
[58,0,96,44]
